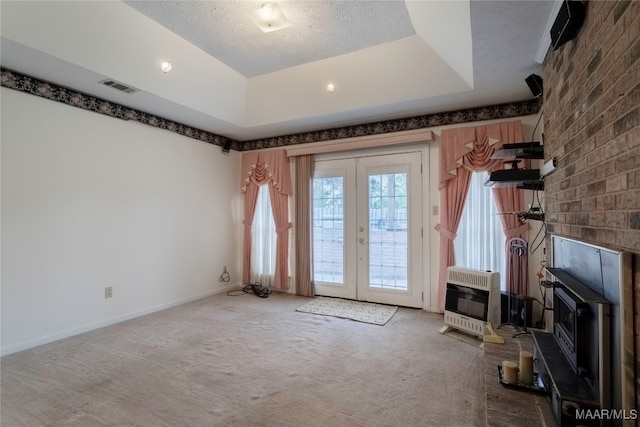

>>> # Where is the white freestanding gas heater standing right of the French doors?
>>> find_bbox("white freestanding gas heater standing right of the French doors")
[440,267,500,338]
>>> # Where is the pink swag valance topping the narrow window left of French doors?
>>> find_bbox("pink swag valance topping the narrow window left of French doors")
[242,149,291,195]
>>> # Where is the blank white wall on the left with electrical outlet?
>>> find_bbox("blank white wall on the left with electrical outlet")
[0,88,241,354]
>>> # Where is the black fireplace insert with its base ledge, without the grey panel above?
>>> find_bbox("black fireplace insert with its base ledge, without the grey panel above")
[533,268,611,427]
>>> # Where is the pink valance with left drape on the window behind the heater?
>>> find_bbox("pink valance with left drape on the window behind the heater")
[435,120,524,310]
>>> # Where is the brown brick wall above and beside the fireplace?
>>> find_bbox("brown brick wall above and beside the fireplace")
[543,1,640,414]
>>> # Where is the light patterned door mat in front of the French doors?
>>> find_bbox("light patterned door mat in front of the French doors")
[296,297,398,325]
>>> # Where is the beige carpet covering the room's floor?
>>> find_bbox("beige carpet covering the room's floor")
[0,293,485,427]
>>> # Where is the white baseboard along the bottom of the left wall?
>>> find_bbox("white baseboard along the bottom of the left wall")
[0,284,240,356]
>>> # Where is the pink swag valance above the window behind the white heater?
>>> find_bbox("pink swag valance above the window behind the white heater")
[439,120,523,188]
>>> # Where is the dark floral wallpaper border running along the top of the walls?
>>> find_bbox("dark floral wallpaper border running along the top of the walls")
[0,67,540,151]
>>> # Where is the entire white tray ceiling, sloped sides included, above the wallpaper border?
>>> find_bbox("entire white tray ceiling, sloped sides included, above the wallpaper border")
[0,0,560,141]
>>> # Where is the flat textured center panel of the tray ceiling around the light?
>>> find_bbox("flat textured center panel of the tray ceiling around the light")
[125,0,415,77]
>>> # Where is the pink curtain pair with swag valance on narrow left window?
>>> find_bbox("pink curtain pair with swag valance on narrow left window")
[242,150,291,288]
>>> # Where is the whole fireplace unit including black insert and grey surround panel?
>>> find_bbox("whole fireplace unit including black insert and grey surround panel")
[532,236,635,427]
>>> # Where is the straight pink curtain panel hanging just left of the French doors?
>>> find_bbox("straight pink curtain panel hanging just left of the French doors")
[295,155,315,297]
